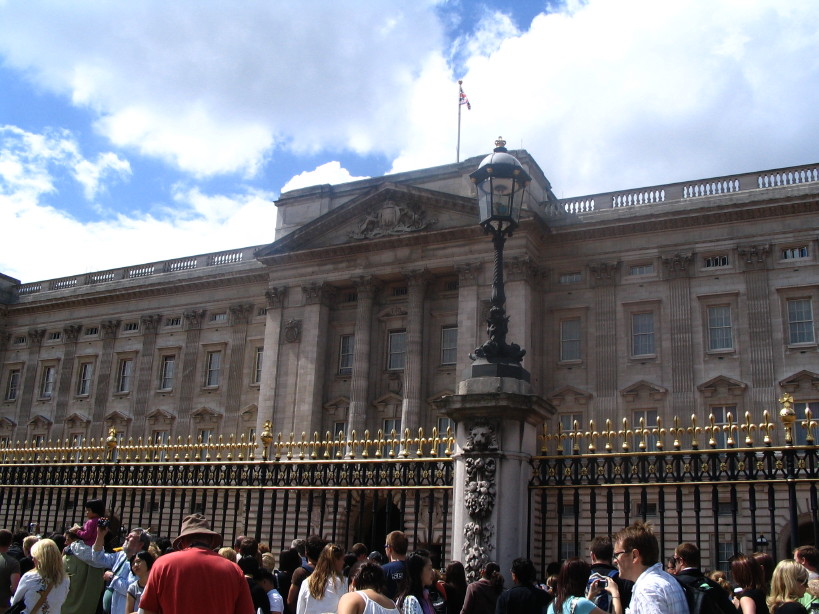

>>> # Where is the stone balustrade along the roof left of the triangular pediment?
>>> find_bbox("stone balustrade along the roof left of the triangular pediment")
[16,245,261,296]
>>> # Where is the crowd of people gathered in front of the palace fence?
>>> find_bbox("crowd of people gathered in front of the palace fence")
[0,500,819,614]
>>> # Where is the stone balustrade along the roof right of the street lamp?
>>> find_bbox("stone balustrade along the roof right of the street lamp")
[557,164,819,214]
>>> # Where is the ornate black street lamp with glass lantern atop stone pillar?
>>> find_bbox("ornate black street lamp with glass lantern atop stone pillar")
[469,138,532,382]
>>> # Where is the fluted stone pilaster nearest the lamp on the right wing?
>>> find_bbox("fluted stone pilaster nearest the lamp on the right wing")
[589,262,620,424]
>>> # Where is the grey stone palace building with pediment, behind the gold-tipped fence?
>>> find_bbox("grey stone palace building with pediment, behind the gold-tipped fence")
[0,151,819,452]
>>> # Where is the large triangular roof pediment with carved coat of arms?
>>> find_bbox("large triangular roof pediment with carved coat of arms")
[256,182,481,263]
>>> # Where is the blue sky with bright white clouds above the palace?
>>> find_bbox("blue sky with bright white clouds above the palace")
[0,0,819,283]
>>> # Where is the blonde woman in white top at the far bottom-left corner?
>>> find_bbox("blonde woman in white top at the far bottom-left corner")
[11,539,70,614]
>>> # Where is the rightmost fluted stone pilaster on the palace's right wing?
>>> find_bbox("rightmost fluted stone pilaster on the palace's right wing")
[737,245,777,415]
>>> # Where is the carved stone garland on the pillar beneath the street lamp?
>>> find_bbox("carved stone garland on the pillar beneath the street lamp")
[463,420,498,581]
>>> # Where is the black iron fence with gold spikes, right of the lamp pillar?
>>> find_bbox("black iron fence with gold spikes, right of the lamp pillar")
[529,395,819,570]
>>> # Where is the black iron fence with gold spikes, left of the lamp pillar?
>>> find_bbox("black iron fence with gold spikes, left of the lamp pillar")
[0,430,453,562]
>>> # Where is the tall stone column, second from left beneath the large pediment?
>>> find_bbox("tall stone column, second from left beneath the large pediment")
[294,283,335,438]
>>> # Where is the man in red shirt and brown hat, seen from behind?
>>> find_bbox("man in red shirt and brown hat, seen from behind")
[139,514,253,614]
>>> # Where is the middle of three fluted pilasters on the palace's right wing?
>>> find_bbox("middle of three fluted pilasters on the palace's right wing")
[656,254,695,416]
